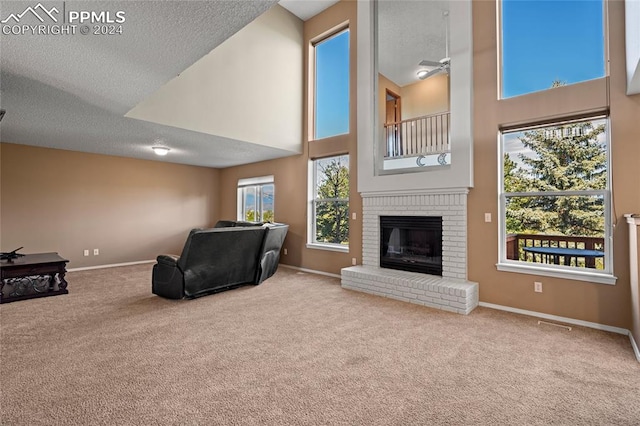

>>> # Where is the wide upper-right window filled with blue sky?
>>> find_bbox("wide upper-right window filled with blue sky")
[500,0,605,98]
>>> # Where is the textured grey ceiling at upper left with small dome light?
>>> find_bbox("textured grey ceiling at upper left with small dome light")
[0,0,292,167]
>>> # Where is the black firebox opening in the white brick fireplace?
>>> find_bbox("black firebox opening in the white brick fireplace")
[380,216,442,276]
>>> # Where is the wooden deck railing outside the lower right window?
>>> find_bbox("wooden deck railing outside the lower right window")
[506,234,604,269]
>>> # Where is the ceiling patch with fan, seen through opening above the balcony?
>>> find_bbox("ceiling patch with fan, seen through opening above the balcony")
[378,0,448,86]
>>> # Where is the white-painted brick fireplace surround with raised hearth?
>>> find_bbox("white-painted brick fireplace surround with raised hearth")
[342,189,478,314]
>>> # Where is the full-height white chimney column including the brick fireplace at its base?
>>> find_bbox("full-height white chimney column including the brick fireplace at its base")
[352,1,478,314]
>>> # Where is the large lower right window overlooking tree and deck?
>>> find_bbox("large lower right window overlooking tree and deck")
[499,117,613,283]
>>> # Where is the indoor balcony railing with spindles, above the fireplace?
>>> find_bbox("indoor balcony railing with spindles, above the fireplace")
[384,112,451,159]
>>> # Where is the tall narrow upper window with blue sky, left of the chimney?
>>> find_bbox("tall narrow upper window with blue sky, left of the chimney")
[313,29,349,139]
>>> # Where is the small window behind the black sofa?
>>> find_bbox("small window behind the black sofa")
[238,176,275,222]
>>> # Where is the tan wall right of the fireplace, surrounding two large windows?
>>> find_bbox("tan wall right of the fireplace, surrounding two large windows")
[468,0,640,328]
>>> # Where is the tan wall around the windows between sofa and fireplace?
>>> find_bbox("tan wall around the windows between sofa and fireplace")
[220,1,362,274]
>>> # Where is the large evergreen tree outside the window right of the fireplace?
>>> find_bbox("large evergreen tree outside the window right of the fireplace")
[503,119,607,237]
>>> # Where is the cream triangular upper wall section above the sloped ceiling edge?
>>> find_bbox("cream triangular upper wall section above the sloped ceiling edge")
[126,5,304,153]
